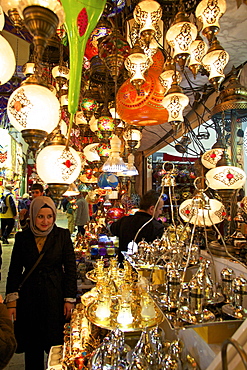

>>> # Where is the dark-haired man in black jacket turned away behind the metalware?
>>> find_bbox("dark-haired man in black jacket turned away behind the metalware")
[110,190,164,262]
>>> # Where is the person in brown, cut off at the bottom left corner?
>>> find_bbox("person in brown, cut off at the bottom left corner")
[0,295,16,370]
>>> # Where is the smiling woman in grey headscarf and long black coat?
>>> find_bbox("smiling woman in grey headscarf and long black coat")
[6,196,77,370]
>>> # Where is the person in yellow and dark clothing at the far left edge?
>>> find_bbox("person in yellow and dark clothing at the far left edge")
[0,184,17,244]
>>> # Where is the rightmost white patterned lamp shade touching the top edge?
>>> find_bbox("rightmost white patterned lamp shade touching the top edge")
[196,0,226,35]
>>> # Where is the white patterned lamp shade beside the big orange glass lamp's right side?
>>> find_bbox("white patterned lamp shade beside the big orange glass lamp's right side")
[162,88,189,122]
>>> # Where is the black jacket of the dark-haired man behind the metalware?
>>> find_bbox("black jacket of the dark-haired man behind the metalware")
[110,211,164,262]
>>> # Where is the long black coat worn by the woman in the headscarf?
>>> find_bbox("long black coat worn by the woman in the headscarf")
[6,225,77,351]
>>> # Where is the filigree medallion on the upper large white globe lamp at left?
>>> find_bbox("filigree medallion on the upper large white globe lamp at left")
[9,89,33,128]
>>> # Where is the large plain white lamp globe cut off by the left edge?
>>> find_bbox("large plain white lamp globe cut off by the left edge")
[0,35,16,85]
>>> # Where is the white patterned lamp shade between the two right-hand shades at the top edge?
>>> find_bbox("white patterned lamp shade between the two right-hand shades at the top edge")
[166,18,197,58]
